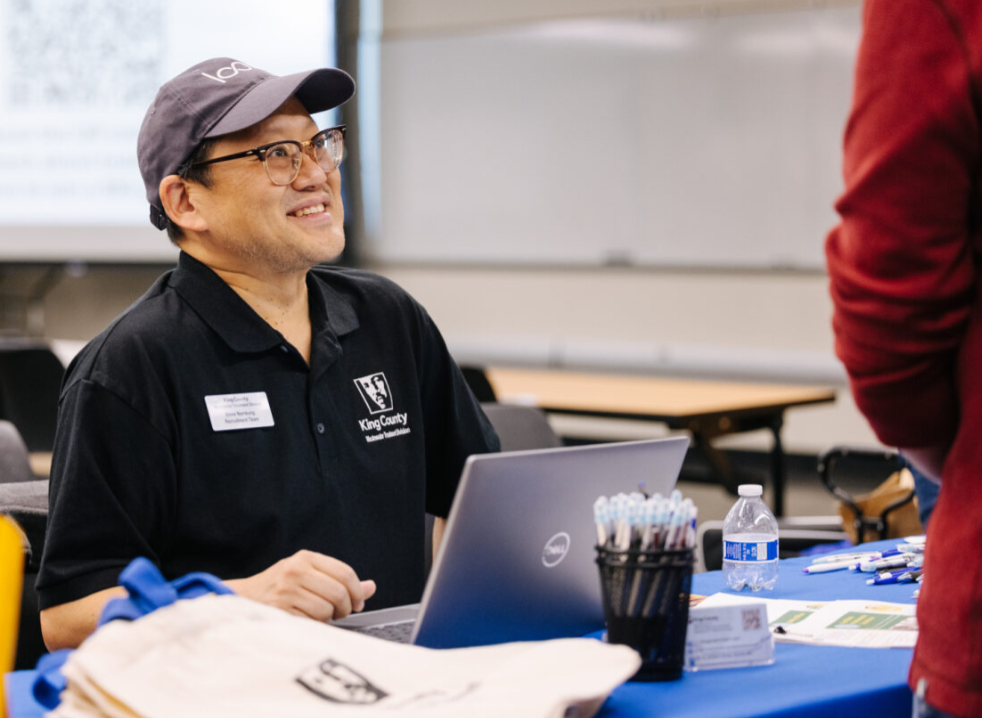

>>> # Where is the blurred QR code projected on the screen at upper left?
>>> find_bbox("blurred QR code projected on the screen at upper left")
[0,0,165,108]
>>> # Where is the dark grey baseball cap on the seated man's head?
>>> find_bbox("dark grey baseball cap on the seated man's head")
[136,57,355,229]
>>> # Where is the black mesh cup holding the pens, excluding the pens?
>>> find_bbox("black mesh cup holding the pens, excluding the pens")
[597,546,693,681]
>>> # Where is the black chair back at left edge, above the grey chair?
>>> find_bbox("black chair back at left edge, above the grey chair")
[0,342,65,452]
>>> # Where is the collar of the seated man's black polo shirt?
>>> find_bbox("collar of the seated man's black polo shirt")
[171,252,359,353]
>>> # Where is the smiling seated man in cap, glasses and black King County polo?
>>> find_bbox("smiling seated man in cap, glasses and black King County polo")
[37,58,498,648]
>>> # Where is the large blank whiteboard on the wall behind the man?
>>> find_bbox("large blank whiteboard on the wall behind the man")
[366,6,860,268]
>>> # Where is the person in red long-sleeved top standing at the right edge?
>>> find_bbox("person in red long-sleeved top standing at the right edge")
[826,0,982,718]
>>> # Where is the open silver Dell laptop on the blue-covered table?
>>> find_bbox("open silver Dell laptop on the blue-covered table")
[332,436,689,648]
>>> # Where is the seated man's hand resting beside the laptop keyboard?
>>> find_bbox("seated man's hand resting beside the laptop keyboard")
[225,551,375,621]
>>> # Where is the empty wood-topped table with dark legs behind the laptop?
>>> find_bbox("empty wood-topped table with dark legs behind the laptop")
[485,367,835,516]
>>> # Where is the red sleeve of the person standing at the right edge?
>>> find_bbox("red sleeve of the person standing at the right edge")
[826,0,979,447]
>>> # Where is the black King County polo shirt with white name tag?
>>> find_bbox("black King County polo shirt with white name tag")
[37,254,498,608]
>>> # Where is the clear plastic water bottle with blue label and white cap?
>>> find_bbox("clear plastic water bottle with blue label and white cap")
[723,484,778,591]
